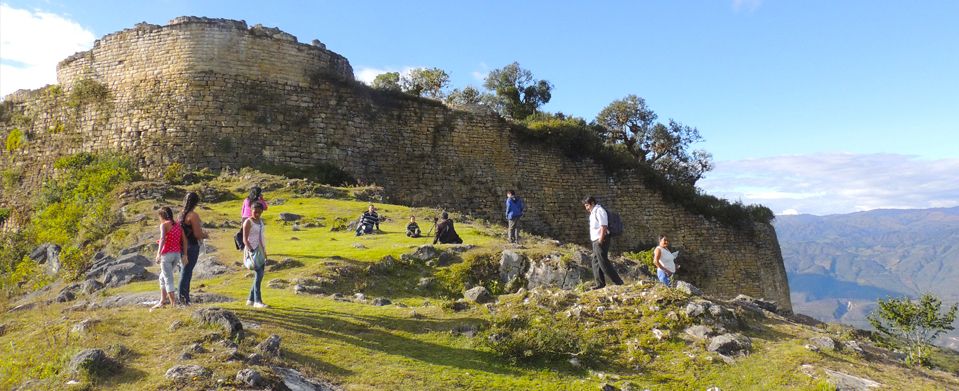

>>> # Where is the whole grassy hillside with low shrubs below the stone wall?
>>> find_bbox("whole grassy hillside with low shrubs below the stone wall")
[0,174,959,390]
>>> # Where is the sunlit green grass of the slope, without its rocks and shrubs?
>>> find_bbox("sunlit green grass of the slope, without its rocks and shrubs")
[0,176,959,390]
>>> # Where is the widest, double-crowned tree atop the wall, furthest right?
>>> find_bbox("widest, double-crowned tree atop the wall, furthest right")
[596,95,713,186]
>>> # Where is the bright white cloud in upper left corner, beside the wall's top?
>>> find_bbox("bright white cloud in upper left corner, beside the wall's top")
[0,4,95,97]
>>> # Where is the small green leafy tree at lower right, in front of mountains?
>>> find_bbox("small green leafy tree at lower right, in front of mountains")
[867,293,957,366]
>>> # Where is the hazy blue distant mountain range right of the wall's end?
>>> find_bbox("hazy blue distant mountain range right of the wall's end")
[774,208,959,349]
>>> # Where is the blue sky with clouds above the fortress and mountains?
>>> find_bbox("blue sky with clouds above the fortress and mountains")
[0,0,959,214]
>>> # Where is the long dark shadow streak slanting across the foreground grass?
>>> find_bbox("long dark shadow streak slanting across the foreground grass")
[237,308,519,375]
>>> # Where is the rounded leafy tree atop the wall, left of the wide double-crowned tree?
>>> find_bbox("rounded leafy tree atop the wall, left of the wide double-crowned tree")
[483,62,553,120]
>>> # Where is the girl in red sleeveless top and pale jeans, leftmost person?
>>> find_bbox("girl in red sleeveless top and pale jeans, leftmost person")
[153,206,189,308]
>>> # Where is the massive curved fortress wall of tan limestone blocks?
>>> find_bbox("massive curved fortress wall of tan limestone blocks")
[0,17,790,309]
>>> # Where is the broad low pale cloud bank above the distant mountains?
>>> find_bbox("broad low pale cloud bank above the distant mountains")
[699,154,959,215]
